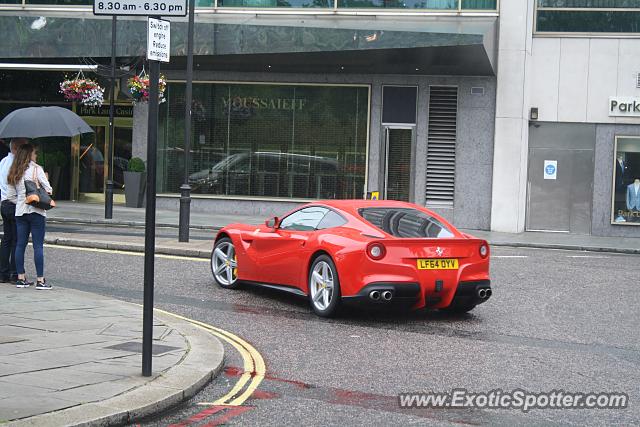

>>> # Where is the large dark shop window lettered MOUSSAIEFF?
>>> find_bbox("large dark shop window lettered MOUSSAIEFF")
[158,83,369,199]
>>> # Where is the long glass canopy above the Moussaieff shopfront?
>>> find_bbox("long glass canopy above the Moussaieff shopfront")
[0,12,497,76]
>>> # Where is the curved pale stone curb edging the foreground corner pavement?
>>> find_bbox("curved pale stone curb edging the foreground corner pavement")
[5,302,224,426]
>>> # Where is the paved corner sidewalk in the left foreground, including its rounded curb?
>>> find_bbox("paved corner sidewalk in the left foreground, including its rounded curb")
[0,284,224,426]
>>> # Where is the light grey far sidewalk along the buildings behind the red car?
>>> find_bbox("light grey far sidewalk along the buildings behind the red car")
[41,202,640,258]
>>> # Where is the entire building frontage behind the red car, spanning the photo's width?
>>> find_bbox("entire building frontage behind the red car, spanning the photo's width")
[0,0,640,236]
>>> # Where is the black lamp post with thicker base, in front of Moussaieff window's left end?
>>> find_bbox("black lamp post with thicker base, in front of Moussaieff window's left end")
[178,0,195,242]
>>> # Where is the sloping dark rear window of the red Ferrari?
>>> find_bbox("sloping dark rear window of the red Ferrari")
[358,208,453,238]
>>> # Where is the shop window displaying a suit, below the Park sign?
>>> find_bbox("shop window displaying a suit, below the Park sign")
[612,136,640,225]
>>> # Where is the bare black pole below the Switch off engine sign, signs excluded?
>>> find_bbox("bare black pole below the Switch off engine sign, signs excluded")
[142,27,160,377]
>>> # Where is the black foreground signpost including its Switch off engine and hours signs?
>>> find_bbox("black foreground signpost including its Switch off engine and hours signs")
[93,0,182,377]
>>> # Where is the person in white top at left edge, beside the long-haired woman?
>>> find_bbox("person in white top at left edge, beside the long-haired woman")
[0,138,27,283]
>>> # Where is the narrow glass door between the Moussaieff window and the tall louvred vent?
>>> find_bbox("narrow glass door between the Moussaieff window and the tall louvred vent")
[385,127,414,202]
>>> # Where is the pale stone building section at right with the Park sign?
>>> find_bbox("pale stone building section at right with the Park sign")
[491,0,640,237]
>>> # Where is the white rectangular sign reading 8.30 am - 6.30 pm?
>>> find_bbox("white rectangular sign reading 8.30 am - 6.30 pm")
[93,0,187,16]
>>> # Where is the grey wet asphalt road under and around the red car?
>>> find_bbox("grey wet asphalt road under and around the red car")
[36,242,640,426]
